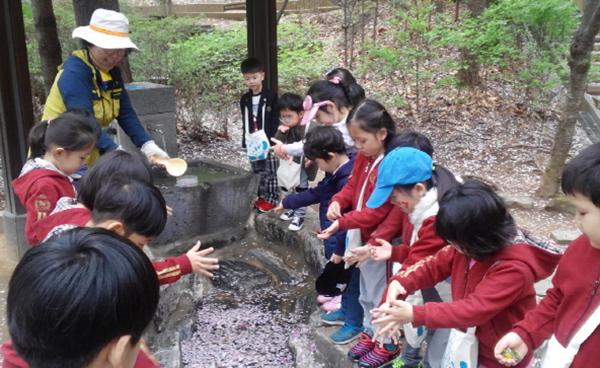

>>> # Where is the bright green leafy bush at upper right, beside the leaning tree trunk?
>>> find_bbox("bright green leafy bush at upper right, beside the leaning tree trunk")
[445,0,578,104]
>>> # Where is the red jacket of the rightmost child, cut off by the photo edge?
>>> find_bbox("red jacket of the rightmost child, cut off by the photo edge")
[513,235,600,368]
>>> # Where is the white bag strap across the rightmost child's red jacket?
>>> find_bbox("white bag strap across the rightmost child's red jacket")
[542,305,600,368]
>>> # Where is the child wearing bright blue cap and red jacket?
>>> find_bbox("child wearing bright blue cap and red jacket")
[367,147,457,368]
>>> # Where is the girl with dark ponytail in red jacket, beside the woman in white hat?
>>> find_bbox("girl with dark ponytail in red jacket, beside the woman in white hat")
[12,111,100,245]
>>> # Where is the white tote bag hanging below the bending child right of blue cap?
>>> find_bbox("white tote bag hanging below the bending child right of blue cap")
[442,327,479,368]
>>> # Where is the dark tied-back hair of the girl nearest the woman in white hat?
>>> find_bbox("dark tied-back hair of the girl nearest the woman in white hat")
[28,110,100,158]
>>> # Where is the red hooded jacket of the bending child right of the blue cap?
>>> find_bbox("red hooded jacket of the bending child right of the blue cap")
[392,232,561,368]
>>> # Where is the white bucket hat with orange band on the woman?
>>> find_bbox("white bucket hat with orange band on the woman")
[72,9,139,50]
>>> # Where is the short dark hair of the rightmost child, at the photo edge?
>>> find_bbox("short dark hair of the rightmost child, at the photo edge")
[562,143,600,207]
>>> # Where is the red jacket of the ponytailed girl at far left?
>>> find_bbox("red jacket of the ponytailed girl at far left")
[12,163,76,245]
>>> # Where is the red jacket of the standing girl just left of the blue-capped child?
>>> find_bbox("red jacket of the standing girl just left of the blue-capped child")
[331,153,398,245]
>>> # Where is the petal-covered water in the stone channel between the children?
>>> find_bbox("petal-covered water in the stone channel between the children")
[182,238,322,368]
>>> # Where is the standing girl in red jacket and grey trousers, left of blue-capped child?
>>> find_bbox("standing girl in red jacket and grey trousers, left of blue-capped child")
[319,99,400,367]
